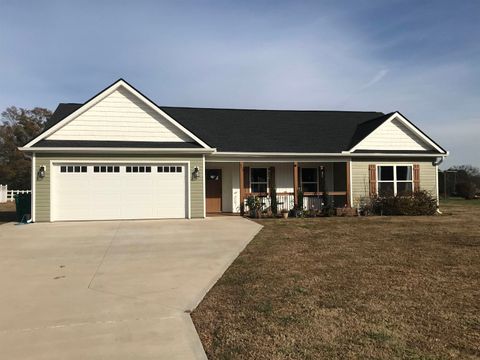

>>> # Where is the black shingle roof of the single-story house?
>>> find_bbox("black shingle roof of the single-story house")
[37,103,446,153]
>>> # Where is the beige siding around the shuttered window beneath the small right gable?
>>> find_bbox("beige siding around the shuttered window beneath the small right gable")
[352,158,437,205]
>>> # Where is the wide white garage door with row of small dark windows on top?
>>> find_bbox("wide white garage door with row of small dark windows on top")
[51,163,188,221]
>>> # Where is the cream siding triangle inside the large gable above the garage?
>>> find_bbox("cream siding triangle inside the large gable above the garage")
[47,87,192,142]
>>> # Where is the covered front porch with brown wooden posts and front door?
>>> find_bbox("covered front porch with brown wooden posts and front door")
[205,161,351,214]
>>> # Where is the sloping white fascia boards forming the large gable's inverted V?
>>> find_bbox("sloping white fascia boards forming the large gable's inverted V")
[23,79,211,149]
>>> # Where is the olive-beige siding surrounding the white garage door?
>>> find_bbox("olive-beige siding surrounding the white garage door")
[34,153,204,222]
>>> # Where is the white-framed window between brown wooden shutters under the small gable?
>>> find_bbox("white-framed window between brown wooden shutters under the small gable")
[377,165,413,196]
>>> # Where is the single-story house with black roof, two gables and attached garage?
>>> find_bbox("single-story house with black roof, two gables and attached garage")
[20,79,448,221]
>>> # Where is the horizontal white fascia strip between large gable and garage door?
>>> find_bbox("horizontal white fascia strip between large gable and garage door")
[18,146,215,154]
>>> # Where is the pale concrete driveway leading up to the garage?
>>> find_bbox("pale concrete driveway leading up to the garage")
[0,217,260,360]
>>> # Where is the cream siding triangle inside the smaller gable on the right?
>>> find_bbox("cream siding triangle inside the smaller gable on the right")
[356,120,431,151]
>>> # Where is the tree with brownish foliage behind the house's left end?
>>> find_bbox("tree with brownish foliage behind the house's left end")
[0,106,52,189]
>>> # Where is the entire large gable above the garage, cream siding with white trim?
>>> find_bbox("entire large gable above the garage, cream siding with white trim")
[26,80,210,148]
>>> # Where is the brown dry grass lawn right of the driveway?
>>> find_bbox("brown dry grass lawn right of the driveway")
[192,200,480,360]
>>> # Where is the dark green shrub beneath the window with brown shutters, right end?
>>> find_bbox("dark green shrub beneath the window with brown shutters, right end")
[369,190,437,216]
